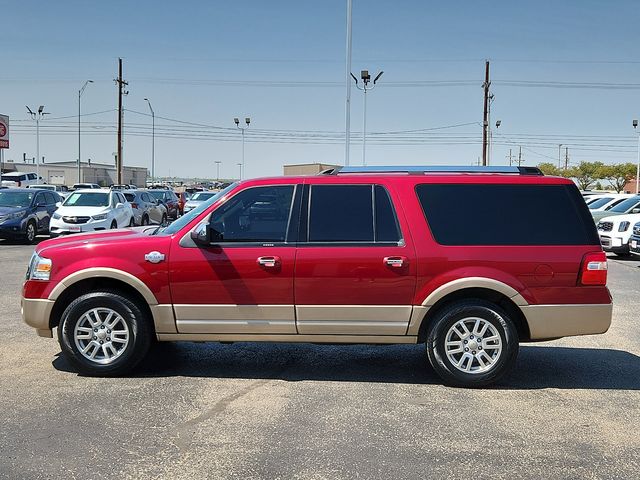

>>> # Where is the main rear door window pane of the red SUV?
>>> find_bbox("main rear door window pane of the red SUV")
[309,185,374,242]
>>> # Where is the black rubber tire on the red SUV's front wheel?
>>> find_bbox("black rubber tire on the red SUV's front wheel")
[58,291,153,377]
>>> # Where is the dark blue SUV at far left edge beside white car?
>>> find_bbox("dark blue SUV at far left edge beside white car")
[0,188,62,243]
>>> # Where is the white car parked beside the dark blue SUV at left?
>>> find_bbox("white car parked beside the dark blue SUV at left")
[49,189,134,237]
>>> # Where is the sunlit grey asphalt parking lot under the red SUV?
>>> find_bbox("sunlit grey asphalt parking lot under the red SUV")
[0,241,640,479]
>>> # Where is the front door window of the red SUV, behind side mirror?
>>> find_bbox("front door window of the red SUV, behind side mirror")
[211,185,294,243]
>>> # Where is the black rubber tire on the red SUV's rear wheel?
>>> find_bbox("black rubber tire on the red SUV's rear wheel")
[426,299,519,387]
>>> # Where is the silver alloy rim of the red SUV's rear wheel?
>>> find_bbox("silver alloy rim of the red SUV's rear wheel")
[445,317,502,374]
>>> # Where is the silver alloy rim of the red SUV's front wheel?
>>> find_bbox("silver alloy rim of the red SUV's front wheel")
[73,307,131,365]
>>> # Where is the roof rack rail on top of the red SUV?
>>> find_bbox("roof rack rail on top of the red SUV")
[328,165,544,175]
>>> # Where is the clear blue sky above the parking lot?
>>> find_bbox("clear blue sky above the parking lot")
[0,0,640,178]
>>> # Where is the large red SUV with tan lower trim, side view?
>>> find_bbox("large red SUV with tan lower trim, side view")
[22,167,612,386]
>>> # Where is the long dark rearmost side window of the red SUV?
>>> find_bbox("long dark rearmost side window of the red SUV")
[416,184,600,245]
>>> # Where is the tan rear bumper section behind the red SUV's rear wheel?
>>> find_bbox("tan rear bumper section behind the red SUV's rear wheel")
[520,303,613,340]
